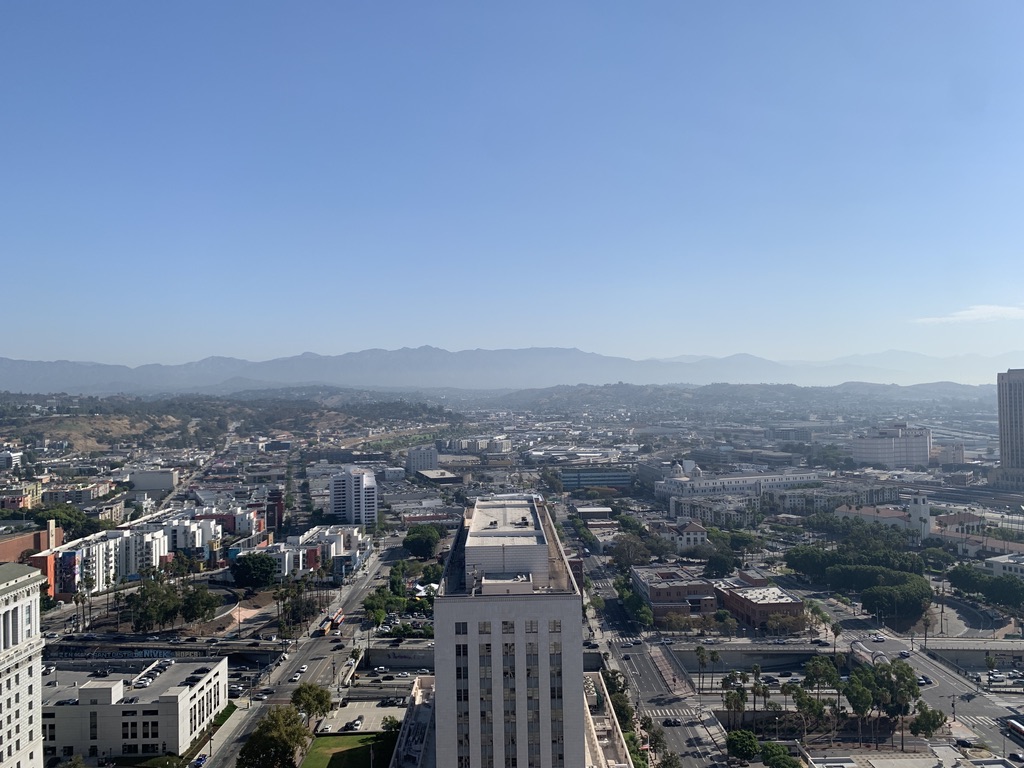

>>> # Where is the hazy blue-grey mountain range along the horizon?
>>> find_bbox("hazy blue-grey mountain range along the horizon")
[0,346,1011,394]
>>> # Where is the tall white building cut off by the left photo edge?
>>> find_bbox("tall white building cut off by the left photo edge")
[0,563,46,768]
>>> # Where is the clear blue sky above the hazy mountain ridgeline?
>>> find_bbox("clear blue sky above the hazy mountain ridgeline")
[0,0,1024,365]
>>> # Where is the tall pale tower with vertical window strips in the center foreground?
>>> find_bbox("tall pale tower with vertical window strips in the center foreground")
[434,496,586,768]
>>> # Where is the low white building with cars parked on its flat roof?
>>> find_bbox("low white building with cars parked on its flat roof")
[41,656,228,766]
